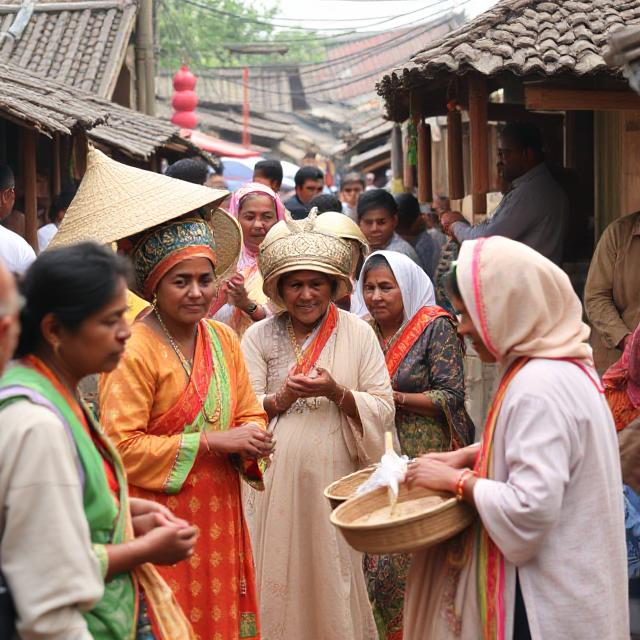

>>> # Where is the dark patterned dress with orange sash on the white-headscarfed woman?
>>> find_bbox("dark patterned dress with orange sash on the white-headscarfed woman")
[364,307,474,640]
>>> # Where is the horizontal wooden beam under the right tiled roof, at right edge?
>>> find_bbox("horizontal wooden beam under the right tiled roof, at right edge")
[524,85,640,111]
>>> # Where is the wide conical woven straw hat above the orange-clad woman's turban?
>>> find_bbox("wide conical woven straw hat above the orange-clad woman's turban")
[49,147,242,276]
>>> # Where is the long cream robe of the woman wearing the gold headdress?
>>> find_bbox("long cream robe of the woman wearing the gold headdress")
[242,311,394,640]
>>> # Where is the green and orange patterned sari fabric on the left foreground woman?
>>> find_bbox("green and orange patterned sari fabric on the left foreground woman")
[0,356,193,640]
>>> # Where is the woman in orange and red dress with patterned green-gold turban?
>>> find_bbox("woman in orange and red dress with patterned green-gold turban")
[100,214,272,638]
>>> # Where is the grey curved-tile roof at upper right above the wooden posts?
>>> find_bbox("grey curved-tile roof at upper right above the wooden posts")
[378,0,640,100]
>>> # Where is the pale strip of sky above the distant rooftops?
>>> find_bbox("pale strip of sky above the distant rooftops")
[278,0,497,31]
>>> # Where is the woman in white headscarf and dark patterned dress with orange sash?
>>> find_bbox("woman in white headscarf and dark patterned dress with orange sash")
[358,251,474,640]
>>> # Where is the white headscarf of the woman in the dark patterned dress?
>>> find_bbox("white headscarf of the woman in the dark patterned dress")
[358,251,436,322]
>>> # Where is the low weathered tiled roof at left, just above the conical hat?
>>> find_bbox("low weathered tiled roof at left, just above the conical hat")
[0,63,210,160]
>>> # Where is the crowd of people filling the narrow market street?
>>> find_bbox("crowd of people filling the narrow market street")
[0,123,640,640]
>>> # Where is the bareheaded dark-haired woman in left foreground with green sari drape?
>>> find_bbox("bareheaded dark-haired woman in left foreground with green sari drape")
[0,243,197,640]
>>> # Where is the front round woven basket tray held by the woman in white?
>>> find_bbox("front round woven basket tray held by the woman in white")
[331,484,475,553]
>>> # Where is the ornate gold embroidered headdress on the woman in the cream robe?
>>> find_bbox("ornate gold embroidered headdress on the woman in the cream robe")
[258,209,351,307]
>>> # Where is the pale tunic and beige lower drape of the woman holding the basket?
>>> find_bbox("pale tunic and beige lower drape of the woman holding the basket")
[405,359,629,640]
